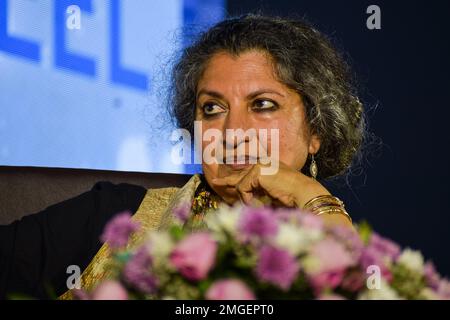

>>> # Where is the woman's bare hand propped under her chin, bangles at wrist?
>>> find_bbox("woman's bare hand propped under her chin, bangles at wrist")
[212,162,351,225]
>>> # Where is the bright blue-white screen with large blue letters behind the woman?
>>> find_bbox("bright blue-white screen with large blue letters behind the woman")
[0,0,224,173]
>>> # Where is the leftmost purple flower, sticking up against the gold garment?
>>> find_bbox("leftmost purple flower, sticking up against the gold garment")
[101,211,139,249]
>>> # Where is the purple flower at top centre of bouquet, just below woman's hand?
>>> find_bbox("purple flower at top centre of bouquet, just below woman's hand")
[238,207,278,241]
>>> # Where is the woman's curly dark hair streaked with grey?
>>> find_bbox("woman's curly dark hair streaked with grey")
[169,14,366,179]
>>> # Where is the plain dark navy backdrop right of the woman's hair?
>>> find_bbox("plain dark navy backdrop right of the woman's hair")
[228,0,450,276]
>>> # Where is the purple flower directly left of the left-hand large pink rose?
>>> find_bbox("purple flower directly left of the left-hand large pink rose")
[123,246,157,294]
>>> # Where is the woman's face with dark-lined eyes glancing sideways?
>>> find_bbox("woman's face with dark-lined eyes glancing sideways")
[196,50,320,203]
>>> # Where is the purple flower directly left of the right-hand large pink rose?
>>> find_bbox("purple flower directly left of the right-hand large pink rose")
[256,245,300,290]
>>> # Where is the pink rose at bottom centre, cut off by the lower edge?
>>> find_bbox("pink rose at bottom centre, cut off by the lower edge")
[205,279,255,300]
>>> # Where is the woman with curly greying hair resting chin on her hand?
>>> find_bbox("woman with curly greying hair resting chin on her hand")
[0,15,364,298]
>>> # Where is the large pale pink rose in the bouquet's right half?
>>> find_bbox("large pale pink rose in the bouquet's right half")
[310,238,355,273]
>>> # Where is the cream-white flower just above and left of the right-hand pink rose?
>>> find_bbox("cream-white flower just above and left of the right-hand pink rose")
[275,223,320,255]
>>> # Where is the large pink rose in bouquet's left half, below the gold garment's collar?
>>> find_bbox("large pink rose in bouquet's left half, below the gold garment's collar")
[170,232,217,281]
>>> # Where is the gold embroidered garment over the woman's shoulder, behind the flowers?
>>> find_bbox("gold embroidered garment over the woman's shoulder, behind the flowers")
[59,175,201,300]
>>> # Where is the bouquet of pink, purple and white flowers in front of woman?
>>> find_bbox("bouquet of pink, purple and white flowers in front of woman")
[78,206,450,300]
